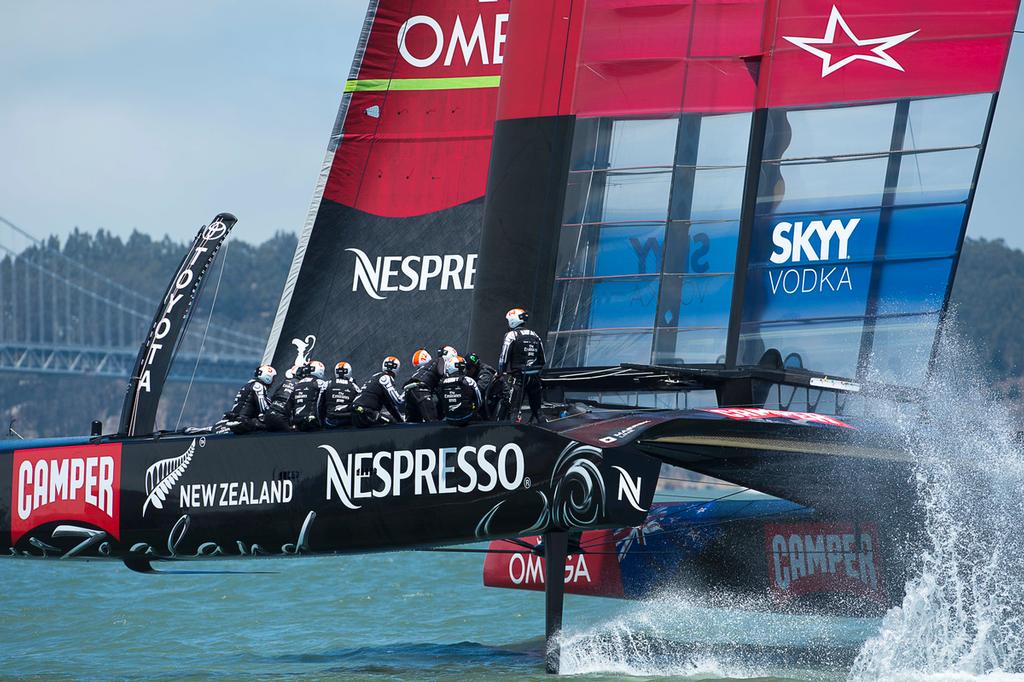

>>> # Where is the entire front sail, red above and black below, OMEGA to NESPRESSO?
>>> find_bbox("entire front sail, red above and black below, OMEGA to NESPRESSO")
[264,0,508,378]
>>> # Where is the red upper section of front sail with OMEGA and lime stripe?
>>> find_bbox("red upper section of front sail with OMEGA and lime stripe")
[324,0,508,217]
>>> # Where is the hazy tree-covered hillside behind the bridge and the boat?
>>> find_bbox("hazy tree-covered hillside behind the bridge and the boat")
[0,230,1024,436]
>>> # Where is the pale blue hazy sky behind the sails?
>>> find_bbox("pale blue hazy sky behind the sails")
[0,0,1024,248]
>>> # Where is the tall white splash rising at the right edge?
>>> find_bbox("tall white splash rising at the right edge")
[850,329,1024,681]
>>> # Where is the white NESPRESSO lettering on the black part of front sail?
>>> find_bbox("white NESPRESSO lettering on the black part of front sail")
[345,244,476,301]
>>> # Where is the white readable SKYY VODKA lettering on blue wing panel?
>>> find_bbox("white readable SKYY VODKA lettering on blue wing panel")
[768,218,860,294]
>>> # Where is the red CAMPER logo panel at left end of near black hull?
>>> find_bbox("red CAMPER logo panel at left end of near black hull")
[10,443,121,542]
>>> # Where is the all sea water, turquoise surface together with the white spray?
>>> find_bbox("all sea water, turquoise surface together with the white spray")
[0,327,1024,681]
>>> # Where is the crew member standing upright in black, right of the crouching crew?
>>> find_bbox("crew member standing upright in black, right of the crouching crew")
[498,308,545,424]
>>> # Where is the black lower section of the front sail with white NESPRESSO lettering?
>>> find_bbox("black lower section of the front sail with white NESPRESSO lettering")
[273,199,483,378]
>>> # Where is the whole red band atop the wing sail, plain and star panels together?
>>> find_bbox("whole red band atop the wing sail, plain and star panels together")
[565,0,1018,117]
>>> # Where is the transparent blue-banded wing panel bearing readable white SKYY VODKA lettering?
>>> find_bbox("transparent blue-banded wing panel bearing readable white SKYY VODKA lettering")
[737,94,991,386]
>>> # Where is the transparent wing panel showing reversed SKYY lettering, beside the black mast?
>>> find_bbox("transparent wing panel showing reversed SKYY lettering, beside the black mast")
[549,114,751,367]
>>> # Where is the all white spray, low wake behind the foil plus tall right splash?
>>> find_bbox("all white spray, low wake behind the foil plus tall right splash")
[561,321,1024,682]
